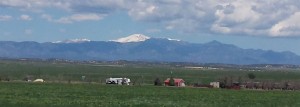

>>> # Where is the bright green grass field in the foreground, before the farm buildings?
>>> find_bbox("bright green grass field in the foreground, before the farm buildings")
[0,83,300,107]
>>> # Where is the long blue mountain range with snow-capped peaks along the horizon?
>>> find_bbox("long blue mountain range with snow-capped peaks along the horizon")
[0,34,300,65]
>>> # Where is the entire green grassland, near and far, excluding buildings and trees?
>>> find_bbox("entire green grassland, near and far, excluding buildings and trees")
[0,61,300,107]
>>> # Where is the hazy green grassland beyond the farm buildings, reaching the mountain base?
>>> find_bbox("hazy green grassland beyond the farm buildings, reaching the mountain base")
[0,61,300,84]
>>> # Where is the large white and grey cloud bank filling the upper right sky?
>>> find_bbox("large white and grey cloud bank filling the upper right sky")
[128,0,300,37]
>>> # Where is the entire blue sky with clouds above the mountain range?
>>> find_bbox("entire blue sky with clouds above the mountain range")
[0,0,300,55]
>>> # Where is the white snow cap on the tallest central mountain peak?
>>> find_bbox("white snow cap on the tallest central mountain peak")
[112,34,150,43]
